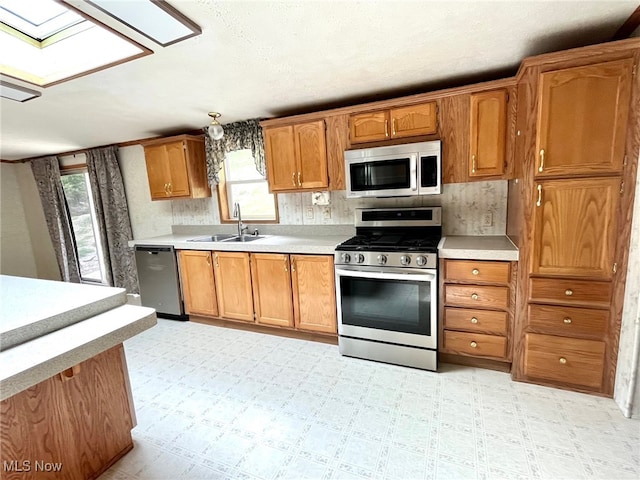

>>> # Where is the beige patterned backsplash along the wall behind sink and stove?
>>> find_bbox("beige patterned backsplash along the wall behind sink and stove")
[171,180,507,235]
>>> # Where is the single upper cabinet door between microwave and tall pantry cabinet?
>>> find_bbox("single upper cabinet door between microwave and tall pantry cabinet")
[468,90,507,177]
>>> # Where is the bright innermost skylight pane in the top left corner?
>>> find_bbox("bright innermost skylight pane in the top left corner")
[0,0,85,42]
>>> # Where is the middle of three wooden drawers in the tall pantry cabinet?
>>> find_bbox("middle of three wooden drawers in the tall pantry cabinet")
[529,304,609,337]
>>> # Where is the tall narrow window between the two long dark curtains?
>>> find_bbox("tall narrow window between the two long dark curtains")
[61,167,107,285]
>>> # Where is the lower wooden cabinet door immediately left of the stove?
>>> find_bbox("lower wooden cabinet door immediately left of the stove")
[291,255,337,333]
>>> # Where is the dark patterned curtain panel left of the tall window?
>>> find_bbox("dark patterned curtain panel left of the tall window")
[31,156,80,283]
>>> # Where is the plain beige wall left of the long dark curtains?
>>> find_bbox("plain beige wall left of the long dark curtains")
[0,163,60,280]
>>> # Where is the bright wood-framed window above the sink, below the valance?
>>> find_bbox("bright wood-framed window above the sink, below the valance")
[218,149,278,223]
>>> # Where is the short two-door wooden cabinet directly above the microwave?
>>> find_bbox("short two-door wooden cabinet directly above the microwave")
[349,102,437,143]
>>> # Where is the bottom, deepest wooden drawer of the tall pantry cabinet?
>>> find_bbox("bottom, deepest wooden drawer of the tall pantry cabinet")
[524,333,605,389]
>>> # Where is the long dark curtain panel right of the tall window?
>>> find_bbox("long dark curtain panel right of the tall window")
[87,146,138,293]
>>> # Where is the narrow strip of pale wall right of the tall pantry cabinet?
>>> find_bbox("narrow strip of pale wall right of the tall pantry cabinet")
[613,150,640,417]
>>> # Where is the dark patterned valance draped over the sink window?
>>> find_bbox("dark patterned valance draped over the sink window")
[203,119,266,187]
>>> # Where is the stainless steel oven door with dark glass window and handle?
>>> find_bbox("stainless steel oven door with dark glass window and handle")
[336,266,438,349]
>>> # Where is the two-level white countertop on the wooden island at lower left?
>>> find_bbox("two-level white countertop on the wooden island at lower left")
[0,276,157,400]
